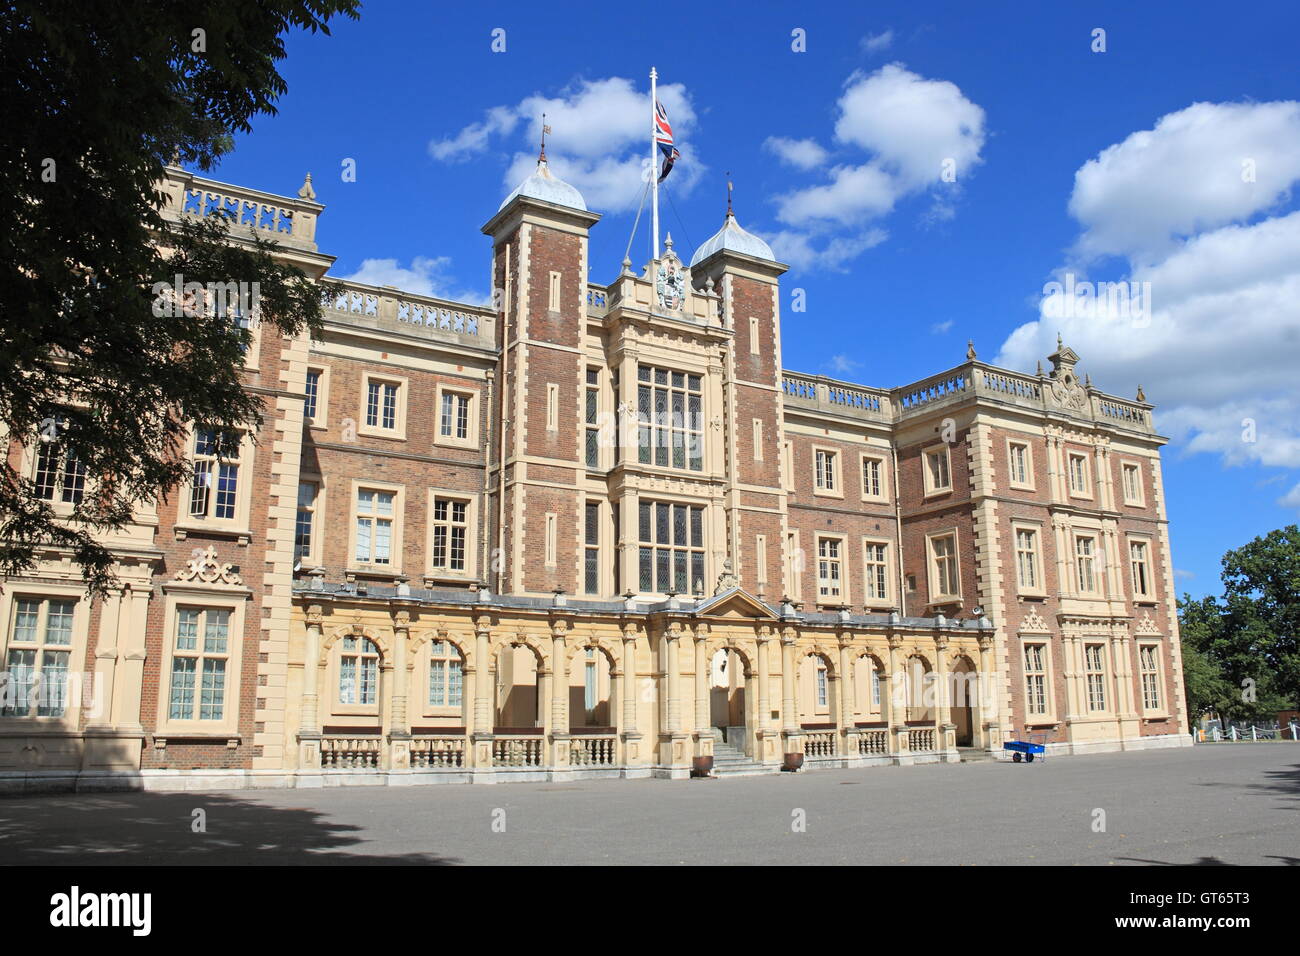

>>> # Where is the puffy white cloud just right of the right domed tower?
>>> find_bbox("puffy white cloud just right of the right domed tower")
[767,64,984,269]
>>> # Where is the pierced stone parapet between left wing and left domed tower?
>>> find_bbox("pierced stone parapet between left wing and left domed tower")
[322,277,497,347]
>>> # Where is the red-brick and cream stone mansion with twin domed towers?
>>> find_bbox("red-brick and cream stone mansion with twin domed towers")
[0,160,1190,790]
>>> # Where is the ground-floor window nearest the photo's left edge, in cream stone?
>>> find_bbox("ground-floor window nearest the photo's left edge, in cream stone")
[0,597,77,717]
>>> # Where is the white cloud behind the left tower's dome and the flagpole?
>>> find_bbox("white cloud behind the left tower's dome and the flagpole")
[429,77,707,213]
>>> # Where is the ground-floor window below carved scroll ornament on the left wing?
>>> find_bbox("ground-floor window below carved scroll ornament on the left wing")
[168,607,230,721]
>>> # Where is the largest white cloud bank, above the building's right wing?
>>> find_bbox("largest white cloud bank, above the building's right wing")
[997,103,1300,481]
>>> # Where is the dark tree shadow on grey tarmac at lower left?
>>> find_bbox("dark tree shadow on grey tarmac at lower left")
[0,793,460,866]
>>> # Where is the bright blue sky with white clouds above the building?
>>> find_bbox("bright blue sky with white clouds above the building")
[205,1,1300,594]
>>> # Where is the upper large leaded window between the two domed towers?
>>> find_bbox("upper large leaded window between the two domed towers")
[637,365,705,471]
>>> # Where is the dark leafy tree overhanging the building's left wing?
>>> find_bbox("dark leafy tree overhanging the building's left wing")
[0,0,359,591]
